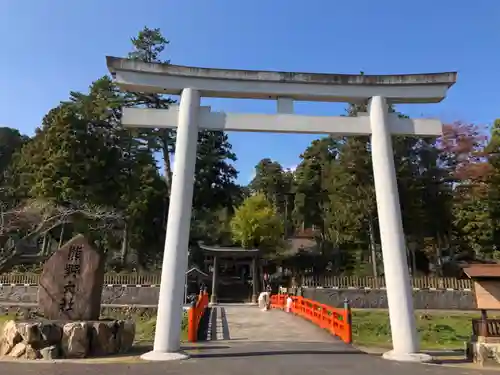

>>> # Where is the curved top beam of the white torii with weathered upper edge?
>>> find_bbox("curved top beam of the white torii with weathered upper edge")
[106,56,457,103]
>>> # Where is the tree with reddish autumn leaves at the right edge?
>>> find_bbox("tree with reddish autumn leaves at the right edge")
[448,122,500,258]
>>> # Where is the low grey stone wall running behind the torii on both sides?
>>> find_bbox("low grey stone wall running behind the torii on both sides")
[0,285,475,310]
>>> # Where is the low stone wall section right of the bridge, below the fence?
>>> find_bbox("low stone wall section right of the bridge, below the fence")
[302,288,476,310]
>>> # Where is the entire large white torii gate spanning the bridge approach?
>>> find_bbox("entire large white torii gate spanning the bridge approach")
[107,57,457,361]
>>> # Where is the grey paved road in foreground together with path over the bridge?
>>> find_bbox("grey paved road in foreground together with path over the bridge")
[0,306,491,375]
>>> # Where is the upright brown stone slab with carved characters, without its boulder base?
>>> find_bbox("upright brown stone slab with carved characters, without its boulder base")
[38,235,104,321]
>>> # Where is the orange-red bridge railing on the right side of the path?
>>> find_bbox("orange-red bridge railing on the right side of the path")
[271,294,352,344]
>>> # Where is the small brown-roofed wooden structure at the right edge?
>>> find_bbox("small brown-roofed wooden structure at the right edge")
[463,264,500,338]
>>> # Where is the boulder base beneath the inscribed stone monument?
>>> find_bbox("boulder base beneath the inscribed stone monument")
[0,320,135,360]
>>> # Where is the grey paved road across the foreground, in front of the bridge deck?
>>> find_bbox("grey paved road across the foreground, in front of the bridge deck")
[0,341,491,375]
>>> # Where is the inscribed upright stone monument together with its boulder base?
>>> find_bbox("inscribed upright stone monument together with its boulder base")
[0,235,135,359]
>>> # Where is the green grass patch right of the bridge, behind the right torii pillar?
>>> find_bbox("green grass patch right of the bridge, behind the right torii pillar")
[352,310,479,349]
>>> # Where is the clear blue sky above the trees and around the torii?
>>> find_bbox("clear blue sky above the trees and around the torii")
[0,0,500,183]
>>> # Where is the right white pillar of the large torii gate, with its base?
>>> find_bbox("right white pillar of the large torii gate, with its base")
[369,96,420,361]
